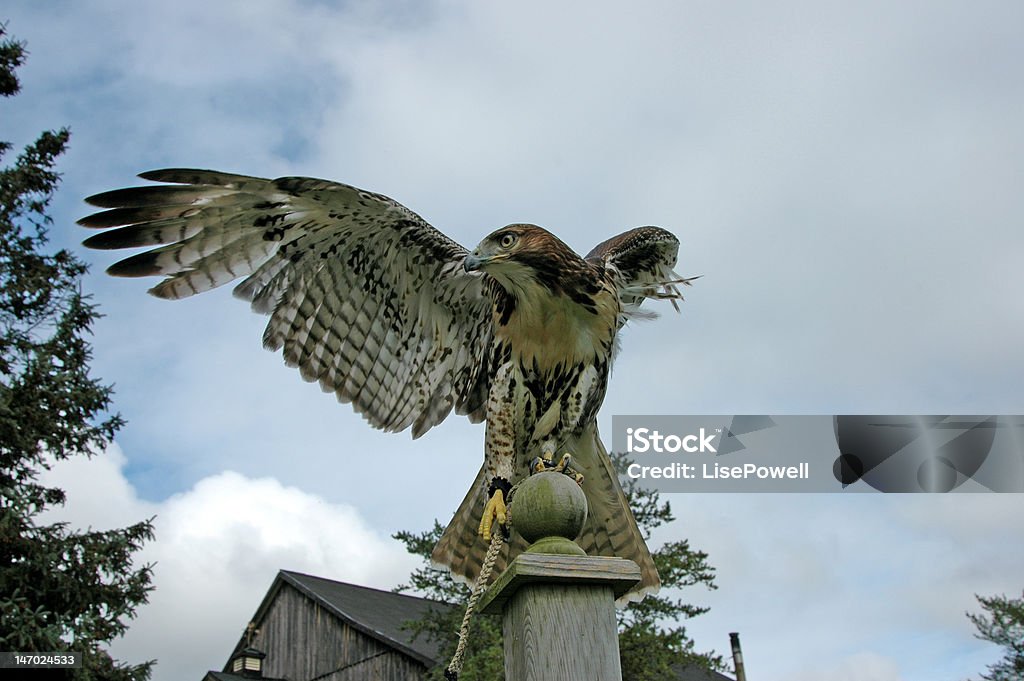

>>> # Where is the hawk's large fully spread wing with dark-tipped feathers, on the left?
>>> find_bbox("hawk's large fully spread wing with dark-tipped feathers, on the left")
[79,170,492,437]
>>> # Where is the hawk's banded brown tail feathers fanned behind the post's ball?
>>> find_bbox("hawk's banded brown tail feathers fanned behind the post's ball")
[431,425,662,604]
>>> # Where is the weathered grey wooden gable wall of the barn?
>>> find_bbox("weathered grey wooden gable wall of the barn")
[253,584,426,681]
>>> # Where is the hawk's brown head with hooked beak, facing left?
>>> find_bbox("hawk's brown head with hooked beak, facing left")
[463,224,588,292]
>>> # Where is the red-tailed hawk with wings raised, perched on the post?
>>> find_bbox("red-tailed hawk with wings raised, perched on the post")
[79,170,686,597]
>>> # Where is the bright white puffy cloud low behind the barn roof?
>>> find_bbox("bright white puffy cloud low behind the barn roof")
[42,445,418,681]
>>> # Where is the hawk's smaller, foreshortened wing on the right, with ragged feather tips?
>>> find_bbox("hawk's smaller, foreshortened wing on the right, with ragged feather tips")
[587,227,697,328]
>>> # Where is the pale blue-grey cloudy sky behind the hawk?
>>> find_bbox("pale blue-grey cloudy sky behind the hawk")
[0,0,1024,681]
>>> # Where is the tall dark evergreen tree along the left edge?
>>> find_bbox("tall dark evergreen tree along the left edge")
[0,25,153,681]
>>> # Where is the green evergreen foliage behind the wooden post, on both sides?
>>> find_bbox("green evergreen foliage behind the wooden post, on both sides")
[394,455,724,681]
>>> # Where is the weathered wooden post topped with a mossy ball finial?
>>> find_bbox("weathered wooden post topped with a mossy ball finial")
[480,472,640,681]
